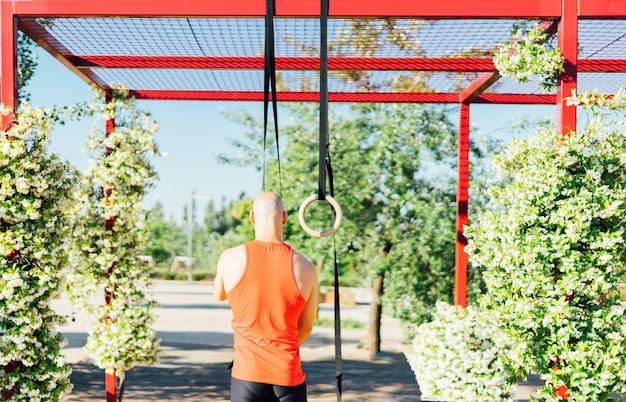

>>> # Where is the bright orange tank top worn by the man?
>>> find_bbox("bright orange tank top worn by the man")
[226,240,306,386]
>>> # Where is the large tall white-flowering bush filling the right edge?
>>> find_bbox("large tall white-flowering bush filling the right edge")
[465,90,626,402]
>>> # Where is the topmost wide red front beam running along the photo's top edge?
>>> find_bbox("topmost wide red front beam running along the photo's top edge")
[12,0,564,18]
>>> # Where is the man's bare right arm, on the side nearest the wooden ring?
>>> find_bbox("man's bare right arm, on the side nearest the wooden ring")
[294,253,319,344]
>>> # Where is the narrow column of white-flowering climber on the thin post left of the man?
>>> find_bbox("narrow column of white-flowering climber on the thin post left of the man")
[67,88,159,381]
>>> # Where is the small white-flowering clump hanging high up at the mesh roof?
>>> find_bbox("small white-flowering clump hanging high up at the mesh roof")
[493,21,565,91]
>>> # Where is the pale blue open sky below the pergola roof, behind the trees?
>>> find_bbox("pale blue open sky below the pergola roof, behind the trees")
[27,49,556,221]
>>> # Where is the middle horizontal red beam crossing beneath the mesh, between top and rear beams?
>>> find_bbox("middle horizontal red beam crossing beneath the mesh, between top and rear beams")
[67,55,496,72]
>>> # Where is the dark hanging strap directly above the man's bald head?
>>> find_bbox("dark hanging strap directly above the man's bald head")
[261,0,283,194]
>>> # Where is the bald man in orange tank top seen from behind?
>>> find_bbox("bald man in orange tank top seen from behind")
[214,193,318,402]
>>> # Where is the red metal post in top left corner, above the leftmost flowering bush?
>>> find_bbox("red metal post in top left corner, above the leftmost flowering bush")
[0,1,17,126]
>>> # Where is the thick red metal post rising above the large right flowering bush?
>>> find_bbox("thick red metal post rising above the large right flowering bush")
[556,0,578,135]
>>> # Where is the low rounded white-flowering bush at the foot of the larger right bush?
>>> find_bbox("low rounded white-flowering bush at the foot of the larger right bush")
[407,302,514,402]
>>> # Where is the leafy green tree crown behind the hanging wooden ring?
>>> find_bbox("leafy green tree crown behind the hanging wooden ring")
[217,104,494,352]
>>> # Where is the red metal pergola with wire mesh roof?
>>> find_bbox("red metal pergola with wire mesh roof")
[0,0,626,398]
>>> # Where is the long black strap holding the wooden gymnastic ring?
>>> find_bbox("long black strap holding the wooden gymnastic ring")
[317,0,343,402]
